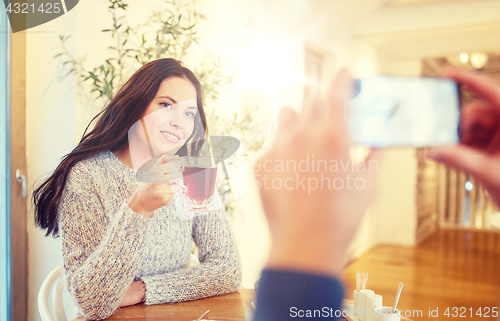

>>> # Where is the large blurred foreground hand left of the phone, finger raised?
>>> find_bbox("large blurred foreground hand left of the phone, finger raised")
[255,71,376,275]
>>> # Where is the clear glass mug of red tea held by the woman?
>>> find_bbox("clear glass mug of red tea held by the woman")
[177,156,218,212]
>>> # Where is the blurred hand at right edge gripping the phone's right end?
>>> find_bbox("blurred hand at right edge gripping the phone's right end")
[427,69,500,205]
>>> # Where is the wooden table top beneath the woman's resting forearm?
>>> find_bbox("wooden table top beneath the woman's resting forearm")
[76,289,255,321]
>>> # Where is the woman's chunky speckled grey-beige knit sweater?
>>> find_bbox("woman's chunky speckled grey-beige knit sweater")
[59,150,241,319]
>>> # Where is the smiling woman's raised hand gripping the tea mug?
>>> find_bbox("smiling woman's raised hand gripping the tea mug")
[128,156,181,218]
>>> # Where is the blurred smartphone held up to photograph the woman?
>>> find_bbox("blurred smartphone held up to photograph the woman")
[346,76,460,148]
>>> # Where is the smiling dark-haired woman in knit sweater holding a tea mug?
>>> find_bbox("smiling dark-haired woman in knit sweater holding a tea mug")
[33,59,241,319]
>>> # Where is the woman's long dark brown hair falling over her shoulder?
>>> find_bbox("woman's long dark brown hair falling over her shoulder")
[33,58,207,237]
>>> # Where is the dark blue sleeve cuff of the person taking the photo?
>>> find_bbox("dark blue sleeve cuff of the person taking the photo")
[254,269,343,321]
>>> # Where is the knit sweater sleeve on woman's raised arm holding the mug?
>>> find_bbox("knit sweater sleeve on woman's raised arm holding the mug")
[59,170,154,319]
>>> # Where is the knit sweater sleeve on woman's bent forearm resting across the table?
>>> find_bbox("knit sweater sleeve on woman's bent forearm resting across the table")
[143,205,241,305]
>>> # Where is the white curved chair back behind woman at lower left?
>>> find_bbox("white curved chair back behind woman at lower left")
[38,265,68,321]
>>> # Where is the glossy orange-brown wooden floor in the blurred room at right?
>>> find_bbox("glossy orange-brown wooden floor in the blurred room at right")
[344,230,500,320]
